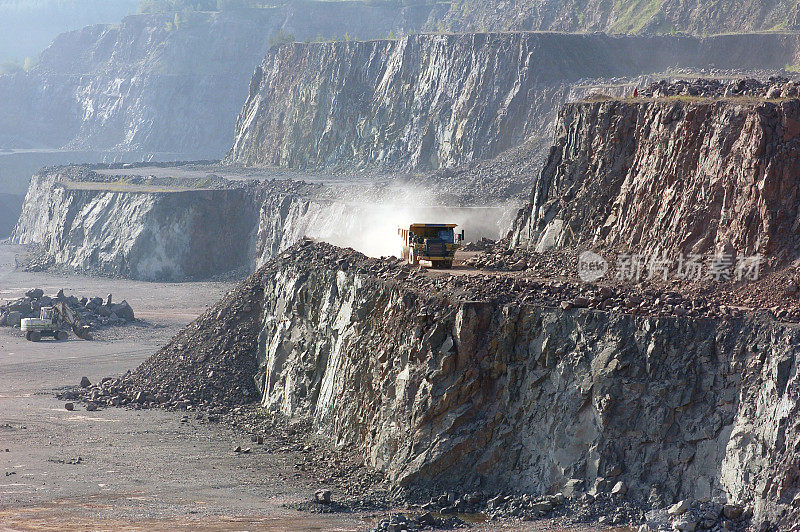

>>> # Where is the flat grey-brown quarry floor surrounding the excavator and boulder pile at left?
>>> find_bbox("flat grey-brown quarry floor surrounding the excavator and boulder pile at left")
[0,245,366,530]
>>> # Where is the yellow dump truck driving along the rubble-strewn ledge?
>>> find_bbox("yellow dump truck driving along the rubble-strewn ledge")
[397,224,464,268]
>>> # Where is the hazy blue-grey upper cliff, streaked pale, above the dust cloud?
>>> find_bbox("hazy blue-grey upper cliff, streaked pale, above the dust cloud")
[228,33,798,168]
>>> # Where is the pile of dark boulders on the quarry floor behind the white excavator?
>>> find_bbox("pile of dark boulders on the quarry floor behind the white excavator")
[0,288,136,329]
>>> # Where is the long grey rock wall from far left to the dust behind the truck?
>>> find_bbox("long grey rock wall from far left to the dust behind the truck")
[14,167,518,281]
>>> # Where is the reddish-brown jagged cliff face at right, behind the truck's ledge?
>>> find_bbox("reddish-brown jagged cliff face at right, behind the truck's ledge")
[514,99,800,260]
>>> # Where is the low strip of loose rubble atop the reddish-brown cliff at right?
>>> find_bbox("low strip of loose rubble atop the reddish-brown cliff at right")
[640,77,800,99]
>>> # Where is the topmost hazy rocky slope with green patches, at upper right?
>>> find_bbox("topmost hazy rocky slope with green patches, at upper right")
[428,0,800,35]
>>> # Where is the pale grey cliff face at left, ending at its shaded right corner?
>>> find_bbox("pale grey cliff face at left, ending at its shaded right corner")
[14,174,257,281]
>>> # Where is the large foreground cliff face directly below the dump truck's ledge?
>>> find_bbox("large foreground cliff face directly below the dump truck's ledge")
[234,246,800,524]
